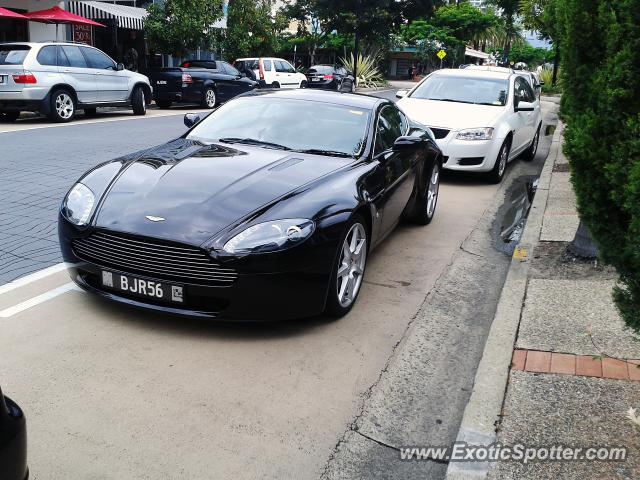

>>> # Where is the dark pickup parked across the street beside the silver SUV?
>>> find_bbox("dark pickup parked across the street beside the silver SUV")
[151,60,258,108]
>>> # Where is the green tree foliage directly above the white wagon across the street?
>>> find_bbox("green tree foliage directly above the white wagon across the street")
[223,0,289,60]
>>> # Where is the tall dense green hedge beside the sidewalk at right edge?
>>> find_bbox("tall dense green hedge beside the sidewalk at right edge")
[553,0,640,331]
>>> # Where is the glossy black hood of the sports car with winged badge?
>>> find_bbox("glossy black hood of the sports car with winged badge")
[95,141,349,245]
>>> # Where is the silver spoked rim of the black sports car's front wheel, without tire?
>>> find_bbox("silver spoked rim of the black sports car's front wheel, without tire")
[336,223,367,308]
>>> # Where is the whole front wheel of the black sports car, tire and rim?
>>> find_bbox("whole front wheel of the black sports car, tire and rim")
[325,214,369,318]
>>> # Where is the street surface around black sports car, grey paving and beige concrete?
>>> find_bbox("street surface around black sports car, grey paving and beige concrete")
[0,92,548,480]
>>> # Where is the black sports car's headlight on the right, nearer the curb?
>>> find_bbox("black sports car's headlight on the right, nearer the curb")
[223,218,315,254]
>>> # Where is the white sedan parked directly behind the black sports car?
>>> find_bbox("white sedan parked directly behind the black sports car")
[397,67,542,183]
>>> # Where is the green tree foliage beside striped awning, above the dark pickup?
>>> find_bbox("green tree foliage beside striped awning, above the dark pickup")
[145,0,222,56]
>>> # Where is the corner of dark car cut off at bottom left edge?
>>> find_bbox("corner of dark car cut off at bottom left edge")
[0,388,29,480]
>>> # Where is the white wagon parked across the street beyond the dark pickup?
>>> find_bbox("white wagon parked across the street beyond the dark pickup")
[234,57,308,88]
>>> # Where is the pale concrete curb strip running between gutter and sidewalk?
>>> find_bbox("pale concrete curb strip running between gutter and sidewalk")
[446,121,564,480]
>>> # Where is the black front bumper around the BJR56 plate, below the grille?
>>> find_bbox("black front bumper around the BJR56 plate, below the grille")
[59,220,335,321]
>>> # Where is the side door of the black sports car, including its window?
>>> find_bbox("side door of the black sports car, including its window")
[374,105,418,233]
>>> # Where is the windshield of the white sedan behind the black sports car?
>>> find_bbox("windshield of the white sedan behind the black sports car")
[411,75,509,106]
